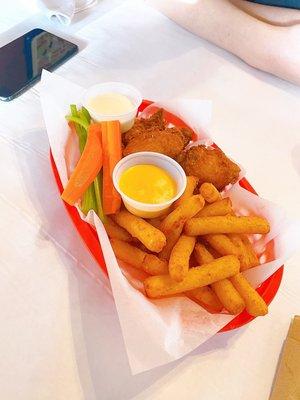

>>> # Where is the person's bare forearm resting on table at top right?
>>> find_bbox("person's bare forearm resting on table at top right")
[147,0,300,84]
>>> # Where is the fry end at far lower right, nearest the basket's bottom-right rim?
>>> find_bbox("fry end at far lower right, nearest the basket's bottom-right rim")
[230,273,268,317]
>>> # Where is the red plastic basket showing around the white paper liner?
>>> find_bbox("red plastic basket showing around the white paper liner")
[50,100,283,332]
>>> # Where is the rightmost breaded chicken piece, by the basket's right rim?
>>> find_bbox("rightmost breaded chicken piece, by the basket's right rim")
[177,145,240,190]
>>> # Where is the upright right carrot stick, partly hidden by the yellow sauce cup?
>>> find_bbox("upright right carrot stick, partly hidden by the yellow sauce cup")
[101,121,122,214]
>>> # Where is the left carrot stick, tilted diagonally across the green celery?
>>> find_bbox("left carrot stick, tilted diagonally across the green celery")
[61,124,102,205]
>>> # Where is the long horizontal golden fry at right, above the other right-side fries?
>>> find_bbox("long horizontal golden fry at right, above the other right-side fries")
[184,215,270,236]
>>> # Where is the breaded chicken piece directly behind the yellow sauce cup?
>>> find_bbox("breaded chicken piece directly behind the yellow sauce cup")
[123,128,186,158]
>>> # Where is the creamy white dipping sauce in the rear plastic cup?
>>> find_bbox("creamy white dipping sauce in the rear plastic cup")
[87,93,134,115]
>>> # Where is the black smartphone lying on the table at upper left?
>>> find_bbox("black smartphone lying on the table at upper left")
[0,29,78,101]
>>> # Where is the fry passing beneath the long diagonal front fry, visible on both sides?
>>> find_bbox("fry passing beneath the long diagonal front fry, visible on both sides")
[195,243,245,315]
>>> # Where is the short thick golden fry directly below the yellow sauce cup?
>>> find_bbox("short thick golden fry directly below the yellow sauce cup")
[114,210,166,253]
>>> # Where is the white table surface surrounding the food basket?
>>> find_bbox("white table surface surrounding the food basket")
[0,0,300,400]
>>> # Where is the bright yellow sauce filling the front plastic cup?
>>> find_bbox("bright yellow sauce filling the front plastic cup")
[119,164,177,204]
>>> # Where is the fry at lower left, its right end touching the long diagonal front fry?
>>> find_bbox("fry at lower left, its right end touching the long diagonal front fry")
[111,239,168,275]
